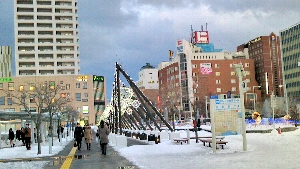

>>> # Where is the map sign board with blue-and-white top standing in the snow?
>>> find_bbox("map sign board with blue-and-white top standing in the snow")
[210,98,241,136]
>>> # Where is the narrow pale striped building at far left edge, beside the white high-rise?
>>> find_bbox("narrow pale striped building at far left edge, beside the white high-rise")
[0,46,12,78]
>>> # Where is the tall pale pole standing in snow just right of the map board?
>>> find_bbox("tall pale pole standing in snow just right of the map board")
[233,63,247,151]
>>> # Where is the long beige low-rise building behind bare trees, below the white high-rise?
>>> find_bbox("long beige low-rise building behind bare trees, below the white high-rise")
[0,75,106,124]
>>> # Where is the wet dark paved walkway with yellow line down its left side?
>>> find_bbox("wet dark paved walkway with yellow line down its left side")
[45,134,147,169]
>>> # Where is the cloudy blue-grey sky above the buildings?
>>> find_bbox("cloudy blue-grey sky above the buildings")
[0,0,300,98]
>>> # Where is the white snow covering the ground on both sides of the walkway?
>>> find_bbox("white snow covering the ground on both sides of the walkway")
[0,123,300,169]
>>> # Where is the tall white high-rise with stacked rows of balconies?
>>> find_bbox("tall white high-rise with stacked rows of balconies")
[14,0,80,76]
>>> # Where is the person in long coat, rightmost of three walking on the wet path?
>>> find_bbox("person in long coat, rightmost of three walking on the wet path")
[98,120,110,155]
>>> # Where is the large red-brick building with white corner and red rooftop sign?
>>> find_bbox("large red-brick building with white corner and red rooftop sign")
[158,31,260,117]
